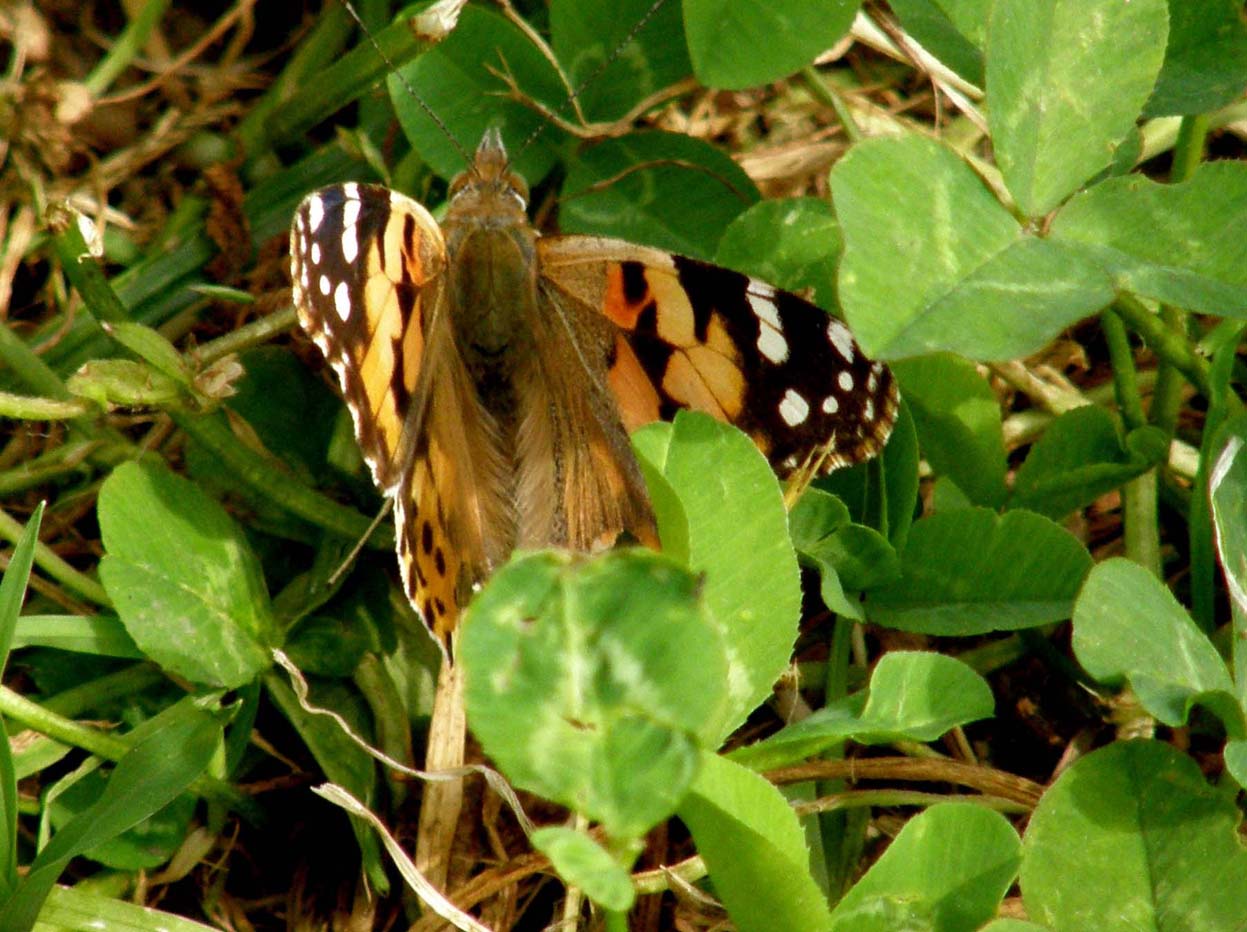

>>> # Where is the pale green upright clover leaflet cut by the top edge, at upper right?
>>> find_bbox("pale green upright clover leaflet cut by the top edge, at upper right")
[986,0,1168,217]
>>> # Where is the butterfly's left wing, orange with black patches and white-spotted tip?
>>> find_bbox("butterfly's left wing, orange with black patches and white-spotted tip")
[291,183,489,635]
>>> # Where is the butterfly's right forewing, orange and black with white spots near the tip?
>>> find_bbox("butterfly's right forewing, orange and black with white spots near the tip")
[537,236,898,473]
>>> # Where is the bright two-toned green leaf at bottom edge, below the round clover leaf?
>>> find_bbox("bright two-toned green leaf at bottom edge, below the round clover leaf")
[680,752,829,932]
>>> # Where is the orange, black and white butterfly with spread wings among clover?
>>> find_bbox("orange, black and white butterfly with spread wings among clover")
[291,130,898,646]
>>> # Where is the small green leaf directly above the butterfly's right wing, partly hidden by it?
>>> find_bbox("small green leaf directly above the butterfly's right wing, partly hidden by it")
[715,197,840,308]
